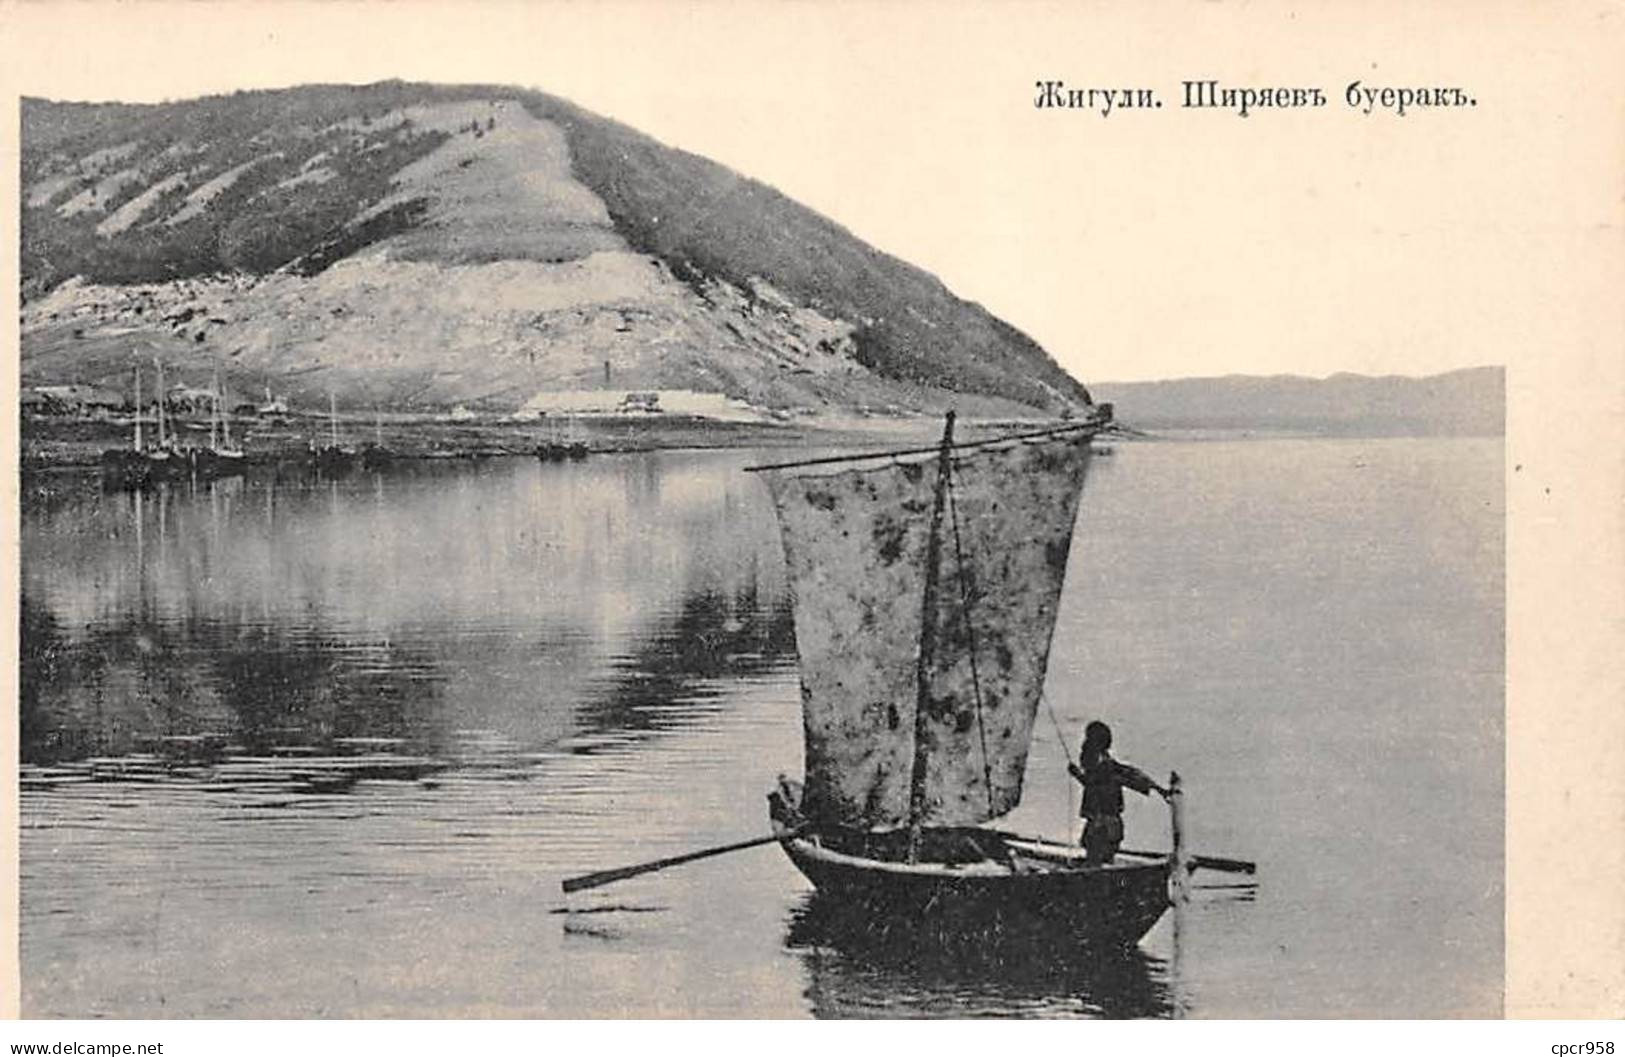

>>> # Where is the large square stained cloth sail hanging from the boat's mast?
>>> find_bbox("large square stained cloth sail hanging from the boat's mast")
[765,429,1092,829]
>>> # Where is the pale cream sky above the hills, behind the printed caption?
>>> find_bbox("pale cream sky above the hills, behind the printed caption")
[0,0,1612,382]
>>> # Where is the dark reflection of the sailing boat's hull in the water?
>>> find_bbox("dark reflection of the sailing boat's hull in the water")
[787,893,1175,1018]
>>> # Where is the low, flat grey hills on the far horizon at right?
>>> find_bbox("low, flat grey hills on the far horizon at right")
[1090,368,1506,436]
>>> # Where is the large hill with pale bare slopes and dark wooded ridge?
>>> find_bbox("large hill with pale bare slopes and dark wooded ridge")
[21,81,1087,415]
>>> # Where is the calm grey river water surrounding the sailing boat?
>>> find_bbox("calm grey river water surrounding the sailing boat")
[21,439,1503,1018]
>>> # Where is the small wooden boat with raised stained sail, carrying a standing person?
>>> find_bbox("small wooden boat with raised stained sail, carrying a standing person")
[754,415,1190,946]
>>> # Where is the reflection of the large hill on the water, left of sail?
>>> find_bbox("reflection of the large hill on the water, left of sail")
[23,455,790,761]
